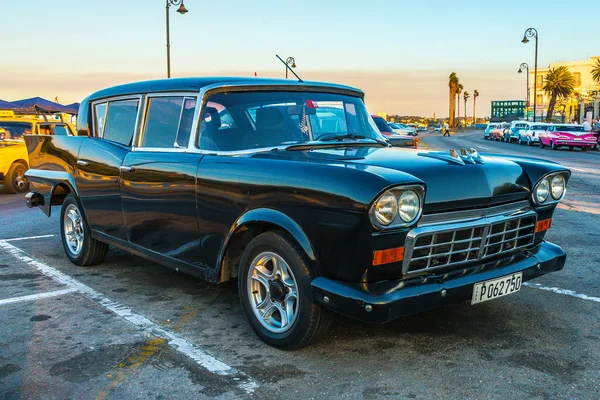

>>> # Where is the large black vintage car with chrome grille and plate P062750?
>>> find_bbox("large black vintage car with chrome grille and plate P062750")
[26,78,570,349]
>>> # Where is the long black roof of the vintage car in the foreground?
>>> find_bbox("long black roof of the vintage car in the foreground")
[88,77,364,100]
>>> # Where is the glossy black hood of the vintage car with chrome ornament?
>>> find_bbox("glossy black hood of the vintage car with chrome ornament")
[262,147,531,213]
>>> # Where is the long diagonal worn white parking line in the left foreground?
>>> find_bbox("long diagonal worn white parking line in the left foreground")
[0,240,258,393]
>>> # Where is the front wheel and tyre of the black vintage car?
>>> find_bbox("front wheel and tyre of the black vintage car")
[238,231,331,350]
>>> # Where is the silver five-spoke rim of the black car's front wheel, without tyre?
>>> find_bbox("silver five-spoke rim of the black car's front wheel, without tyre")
[247,252,298,333]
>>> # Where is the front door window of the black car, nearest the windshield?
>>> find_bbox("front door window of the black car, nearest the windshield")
[141,96,196,148]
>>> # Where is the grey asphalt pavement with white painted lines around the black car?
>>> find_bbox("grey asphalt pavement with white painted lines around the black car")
[0,131,600,399]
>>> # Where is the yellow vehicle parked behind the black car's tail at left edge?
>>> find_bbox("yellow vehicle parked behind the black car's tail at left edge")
[0,110,75,193]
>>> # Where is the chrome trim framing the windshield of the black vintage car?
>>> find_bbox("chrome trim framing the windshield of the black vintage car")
[189,83,364,156]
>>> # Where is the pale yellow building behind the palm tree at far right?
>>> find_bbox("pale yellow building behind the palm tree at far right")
[528,56,600,121]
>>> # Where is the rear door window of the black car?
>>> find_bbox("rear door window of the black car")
[102,99,139,146]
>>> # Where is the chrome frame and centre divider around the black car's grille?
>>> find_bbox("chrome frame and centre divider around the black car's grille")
[402,204,538,277]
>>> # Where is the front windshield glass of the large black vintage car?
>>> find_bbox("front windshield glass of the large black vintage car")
[198,91,389,151]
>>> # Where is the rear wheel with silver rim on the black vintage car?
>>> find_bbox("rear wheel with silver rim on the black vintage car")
[60,193,108,266]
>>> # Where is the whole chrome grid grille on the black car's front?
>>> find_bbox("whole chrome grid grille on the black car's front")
[403,209,537,274]
